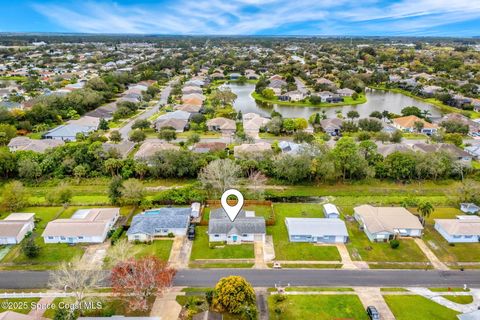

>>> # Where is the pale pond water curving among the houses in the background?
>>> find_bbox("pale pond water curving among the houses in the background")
[225,84,442,119]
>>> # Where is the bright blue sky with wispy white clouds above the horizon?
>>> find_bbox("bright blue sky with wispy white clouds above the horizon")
[0,0,480,36]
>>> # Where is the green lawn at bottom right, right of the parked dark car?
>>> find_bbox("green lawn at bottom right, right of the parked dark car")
[383,295,459,320]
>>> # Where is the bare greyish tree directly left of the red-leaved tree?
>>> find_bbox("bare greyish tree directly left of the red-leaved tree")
[49,257,105,311]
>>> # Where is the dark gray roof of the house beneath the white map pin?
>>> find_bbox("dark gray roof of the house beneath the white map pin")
[208,209,266,235]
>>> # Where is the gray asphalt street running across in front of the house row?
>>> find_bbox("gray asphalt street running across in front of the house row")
[0,269,480,289]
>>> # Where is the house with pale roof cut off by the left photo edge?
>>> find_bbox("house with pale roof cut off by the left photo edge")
[0,213,35,245]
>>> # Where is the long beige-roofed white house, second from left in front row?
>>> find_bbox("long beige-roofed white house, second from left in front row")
[42,208,120,243]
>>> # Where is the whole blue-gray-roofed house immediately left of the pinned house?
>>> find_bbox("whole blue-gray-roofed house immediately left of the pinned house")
[127,208,192,242]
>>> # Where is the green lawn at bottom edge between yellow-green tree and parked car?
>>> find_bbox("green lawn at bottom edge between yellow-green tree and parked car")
[268,295,368,320]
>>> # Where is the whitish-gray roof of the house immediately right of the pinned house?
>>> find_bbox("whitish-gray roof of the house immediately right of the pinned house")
[285,218,348,237]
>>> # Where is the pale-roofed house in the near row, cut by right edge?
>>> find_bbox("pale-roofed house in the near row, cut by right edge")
[435,216,480,243]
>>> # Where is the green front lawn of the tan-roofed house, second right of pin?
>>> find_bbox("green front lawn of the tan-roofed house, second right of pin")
[347,221,428,267]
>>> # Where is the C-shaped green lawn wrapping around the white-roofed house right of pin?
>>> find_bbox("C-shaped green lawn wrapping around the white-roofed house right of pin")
[267,203,340,261]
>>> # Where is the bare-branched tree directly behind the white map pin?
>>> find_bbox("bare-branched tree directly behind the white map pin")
[199,159,241,194]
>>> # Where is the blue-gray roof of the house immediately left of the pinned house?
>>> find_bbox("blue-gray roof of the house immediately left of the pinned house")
[127,208,192,235]
